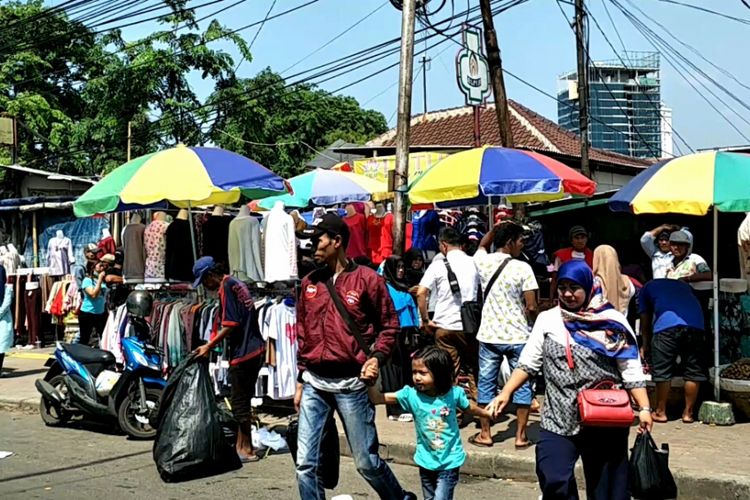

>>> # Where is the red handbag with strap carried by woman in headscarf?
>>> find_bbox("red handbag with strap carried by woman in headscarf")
[565,334,634,427]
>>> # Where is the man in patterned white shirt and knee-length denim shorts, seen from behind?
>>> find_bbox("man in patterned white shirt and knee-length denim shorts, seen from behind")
[469,222,539,449]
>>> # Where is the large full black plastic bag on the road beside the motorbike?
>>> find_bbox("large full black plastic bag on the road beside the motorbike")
[153,356,242,482]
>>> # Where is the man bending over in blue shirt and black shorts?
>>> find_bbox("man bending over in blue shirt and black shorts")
[638,279,708,424]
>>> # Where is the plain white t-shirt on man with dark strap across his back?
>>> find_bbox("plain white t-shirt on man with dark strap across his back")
[419,250,479,331]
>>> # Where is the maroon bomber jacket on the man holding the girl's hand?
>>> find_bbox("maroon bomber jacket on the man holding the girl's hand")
[297,261,400,378]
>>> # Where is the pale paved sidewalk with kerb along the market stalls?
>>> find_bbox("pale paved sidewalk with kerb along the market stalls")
[5,354,750,500]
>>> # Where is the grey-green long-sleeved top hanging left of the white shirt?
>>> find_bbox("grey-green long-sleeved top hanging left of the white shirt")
[228,216,263,281]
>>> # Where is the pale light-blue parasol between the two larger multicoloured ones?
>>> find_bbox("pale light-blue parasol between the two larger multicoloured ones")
[257,168,388,209]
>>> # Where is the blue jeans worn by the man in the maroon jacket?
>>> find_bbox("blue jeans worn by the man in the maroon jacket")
[297,384,410,500]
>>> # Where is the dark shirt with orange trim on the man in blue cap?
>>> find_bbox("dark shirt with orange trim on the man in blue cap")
[219,276,266,365]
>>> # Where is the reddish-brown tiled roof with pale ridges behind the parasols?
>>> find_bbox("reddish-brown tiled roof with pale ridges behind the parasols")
[367,100,653,168]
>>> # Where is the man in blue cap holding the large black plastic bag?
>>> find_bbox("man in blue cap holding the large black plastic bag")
[193,257,265,462]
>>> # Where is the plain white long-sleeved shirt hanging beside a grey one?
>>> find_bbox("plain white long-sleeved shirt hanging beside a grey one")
[264,207,297,282]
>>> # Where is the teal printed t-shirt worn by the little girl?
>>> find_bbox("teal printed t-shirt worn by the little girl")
[396,386,469,470]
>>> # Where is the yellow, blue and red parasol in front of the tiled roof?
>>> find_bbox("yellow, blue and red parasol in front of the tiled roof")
[409,146,596,206]
